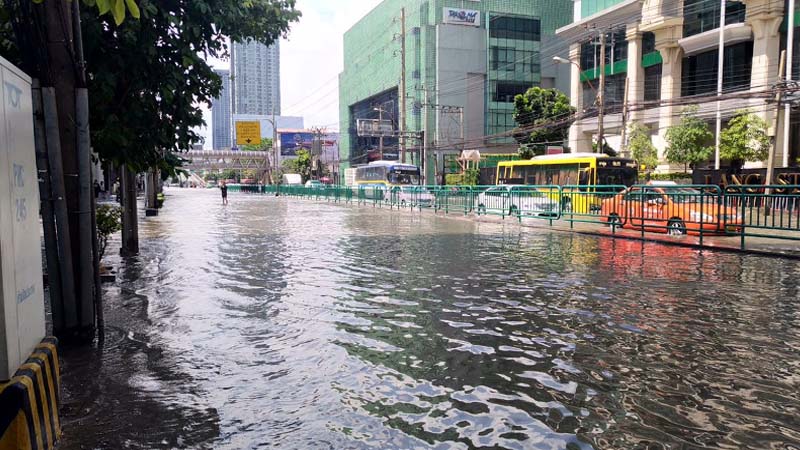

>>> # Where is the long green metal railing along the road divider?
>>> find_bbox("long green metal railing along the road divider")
[229,185,800,253]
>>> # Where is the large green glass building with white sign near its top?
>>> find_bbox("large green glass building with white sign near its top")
[339,0,573,181]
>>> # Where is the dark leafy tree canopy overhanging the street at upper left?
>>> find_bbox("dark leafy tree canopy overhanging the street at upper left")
[0,0,300,172]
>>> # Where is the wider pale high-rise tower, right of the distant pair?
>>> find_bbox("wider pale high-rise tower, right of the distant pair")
[231,42,281,115]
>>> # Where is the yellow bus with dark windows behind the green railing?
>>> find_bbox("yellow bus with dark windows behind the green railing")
[497,153,639,214]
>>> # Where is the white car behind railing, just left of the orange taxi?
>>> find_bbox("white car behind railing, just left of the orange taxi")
[476,186,560,217]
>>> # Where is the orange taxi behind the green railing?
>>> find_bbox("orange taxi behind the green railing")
[601,183,743,236]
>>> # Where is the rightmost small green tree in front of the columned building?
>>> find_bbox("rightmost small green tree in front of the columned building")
[719,110,770,168]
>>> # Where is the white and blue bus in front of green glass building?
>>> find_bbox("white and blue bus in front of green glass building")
[356,161,428,199]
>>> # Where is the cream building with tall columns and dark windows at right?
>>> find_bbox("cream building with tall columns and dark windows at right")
[557,0,800,171]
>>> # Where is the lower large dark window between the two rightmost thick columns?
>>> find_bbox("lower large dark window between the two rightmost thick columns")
[681,42,753,97]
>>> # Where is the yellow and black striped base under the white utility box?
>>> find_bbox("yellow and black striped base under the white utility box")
[0,338,61,450]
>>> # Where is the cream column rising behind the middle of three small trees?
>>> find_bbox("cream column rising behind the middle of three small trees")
[653,27,683,169]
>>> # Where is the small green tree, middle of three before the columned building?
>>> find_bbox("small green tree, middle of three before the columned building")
[665,106,714,172]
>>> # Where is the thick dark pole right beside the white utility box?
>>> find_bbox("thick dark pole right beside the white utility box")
[43,0,95,341]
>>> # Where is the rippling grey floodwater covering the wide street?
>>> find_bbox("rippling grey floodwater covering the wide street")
[61,189,800,449]
